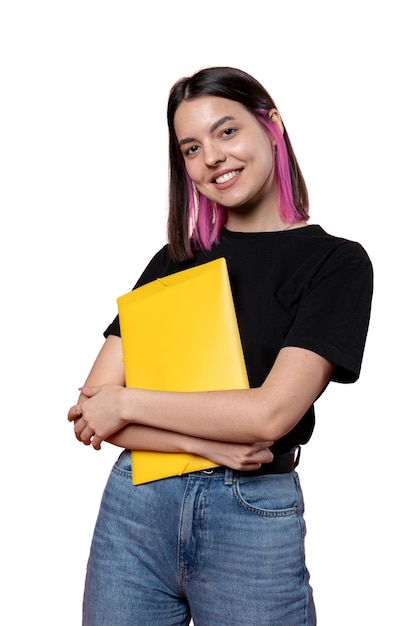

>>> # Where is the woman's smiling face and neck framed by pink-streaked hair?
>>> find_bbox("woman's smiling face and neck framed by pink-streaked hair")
[174,96,281,230]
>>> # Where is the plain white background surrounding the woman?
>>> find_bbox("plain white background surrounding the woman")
[0,0,417,626]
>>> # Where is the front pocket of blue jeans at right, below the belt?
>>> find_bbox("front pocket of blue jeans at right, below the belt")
[233,472,303,517]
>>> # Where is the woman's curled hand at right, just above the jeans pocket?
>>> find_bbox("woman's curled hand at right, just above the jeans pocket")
[197,440,274,471]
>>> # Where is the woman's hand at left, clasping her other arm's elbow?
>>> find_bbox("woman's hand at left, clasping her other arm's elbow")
[68,385,126,450]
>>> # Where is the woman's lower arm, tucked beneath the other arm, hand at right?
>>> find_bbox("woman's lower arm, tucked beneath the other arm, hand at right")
[68,336,273,470]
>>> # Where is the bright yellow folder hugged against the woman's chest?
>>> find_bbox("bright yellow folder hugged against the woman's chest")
[117,258,249,484]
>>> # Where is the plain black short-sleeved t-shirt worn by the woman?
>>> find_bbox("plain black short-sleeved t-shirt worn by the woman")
[104,225,373,452]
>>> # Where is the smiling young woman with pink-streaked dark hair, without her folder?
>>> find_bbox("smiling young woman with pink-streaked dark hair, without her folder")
[68,67,372,626]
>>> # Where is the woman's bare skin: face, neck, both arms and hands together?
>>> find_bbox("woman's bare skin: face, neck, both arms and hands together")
[68,96,334,470]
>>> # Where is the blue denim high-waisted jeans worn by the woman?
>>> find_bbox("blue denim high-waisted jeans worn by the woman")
[83,450,316,626]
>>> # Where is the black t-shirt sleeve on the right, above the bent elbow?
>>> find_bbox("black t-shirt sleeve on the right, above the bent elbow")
[283,241,373,383]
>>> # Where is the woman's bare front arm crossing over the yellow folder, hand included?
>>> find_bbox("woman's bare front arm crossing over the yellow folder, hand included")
[71,347,334,447]
